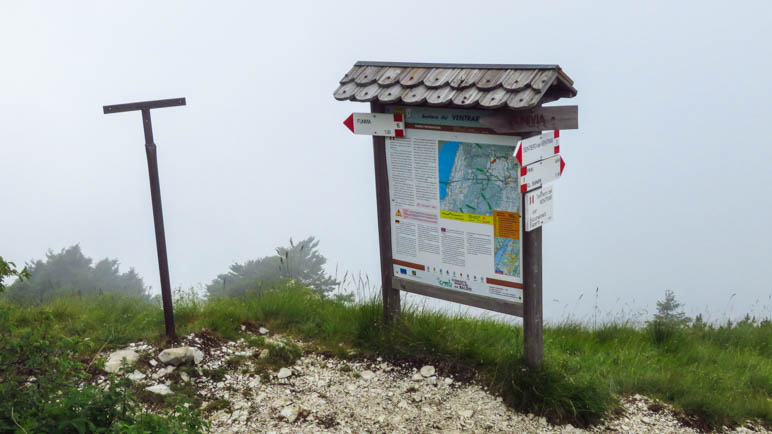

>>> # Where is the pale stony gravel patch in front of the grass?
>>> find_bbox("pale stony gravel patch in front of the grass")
[98,332,769,433]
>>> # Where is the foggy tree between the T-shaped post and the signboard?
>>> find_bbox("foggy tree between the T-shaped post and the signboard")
[206,237,338,297]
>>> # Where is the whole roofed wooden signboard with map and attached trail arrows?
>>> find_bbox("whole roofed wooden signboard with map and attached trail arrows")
[334,62,579,368]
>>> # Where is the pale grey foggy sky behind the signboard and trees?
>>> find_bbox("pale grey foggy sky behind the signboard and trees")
[0,1,772,321]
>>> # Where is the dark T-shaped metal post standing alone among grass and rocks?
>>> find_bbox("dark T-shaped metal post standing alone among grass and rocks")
[103,98,186,339]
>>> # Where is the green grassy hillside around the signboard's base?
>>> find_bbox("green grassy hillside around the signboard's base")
[0,285,772,428]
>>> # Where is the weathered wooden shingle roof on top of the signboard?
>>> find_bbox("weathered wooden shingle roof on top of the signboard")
[334,61,576,110]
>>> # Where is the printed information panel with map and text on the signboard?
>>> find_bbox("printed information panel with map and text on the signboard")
[386,130,523,303]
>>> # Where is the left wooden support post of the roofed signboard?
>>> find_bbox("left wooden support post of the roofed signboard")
[370,103,401,324]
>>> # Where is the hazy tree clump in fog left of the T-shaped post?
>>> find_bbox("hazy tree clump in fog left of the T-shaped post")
[8,244,147,302]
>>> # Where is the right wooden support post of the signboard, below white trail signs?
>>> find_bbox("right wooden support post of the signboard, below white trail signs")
[523,220,544,369]
